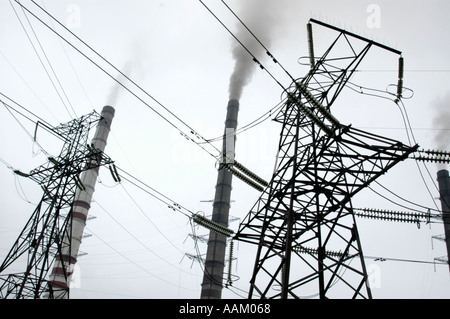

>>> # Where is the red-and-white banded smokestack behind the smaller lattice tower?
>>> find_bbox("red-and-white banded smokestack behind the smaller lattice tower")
[49,106,115,299]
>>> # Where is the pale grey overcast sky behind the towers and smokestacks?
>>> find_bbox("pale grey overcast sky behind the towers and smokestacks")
[0,0,450,298]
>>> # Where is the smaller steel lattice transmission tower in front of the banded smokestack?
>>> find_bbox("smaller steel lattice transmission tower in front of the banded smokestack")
[0,106,114,299]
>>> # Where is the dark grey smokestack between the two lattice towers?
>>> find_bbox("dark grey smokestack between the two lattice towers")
[200,99,239,299]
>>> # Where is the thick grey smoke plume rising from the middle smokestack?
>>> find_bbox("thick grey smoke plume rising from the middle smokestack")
[229,0,292,100]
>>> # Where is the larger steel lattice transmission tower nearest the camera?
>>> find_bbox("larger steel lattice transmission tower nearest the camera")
[235,20,417,298]
